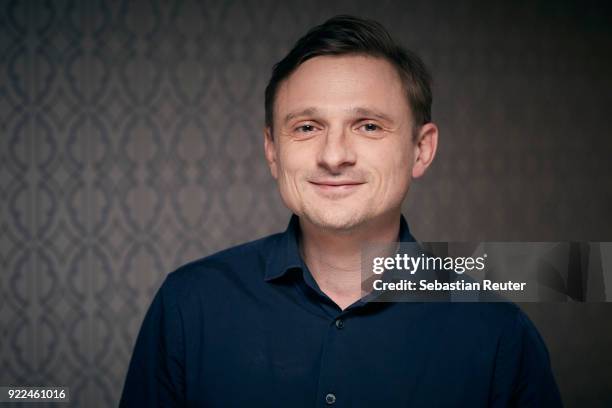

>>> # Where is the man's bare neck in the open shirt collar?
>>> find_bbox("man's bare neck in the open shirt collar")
[300,210,400,309]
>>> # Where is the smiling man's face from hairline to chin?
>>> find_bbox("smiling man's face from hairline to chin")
[265,55,432,231]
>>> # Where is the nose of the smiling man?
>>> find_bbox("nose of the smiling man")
[318,127,356,173]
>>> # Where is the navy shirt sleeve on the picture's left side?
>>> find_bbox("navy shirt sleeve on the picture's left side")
[119,274,185,408]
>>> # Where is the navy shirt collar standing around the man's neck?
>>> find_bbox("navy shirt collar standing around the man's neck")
[264,214,415,281]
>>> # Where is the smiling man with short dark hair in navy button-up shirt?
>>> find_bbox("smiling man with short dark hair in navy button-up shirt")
[121,16,561,407]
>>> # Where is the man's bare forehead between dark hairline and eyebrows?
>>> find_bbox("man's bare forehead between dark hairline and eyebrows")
[274,55,410,120]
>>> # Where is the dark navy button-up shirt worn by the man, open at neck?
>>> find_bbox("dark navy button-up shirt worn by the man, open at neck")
[121,215,561,407]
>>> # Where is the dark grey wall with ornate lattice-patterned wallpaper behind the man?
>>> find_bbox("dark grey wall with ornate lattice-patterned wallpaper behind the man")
[0,0,612,407]
